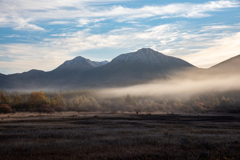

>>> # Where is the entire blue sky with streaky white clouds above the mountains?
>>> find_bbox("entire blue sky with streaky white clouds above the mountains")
[0,0,240,74]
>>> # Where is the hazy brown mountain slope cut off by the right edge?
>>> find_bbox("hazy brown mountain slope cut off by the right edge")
[210,55,240,74]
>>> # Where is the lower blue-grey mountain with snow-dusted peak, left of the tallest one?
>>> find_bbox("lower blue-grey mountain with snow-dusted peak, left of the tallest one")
[0,56,108,89]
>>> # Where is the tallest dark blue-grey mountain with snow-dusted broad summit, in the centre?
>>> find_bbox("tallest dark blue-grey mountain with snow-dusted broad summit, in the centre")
[72,48,196,86]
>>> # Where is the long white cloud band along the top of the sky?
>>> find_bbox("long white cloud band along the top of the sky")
[0,0,237,31]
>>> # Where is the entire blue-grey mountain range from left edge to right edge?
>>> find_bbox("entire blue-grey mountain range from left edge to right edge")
[0,48,240,90]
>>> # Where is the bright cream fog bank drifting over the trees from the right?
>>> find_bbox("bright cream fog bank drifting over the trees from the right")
[97,73,240,98]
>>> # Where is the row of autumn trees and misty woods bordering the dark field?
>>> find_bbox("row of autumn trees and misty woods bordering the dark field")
[0,90,240,114]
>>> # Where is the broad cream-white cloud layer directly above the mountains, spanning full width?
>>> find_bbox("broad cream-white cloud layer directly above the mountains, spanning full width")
[0,22,240,72]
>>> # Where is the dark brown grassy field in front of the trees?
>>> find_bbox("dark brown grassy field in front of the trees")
[0,112,240,160]
